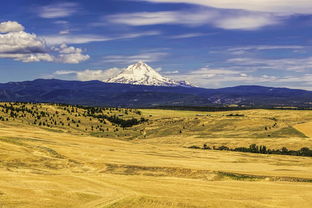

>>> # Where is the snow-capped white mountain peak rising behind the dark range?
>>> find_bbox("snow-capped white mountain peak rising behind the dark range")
[106,61,192,87]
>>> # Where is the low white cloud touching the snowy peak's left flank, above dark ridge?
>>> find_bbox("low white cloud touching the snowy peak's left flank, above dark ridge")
[50,68,122,81]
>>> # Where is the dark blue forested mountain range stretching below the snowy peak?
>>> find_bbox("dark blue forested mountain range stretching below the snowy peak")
[0,79,312,108]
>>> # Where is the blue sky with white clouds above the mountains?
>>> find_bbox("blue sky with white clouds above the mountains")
[0,0,312,90]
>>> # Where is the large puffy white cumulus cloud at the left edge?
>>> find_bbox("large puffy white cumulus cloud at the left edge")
[0,22,89,64]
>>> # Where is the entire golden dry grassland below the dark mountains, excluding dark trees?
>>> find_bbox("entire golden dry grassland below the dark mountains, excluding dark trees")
[0,104,312,208]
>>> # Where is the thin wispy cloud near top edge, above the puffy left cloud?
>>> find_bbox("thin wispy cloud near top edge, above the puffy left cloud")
[38,2,79,18]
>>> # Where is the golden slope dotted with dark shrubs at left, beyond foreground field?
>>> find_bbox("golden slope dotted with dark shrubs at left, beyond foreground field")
[0,103,142,139]
